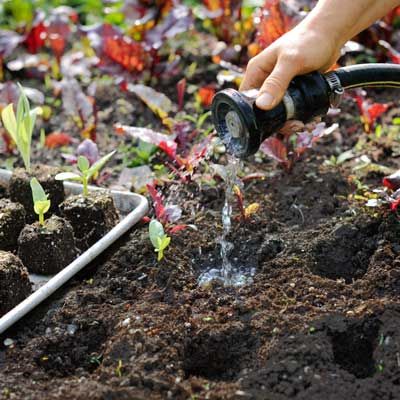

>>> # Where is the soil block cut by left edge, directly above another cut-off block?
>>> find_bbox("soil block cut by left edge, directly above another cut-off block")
[0,199,25,250]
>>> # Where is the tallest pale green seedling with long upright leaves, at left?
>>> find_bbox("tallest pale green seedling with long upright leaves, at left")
[1,84,42,172]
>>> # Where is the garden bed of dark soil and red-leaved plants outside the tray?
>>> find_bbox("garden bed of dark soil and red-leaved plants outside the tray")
[0,0,400,400]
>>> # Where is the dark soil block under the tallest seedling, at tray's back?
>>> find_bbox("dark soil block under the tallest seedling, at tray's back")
[8,165,64,222]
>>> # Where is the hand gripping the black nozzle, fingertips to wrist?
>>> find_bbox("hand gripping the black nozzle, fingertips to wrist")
[240,23,341,110]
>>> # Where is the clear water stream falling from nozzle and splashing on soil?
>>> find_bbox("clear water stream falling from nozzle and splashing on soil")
[199,155,255,286]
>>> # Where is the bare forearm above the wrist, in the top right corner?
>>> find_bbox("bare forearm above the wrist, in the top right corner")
[301,0,400,45]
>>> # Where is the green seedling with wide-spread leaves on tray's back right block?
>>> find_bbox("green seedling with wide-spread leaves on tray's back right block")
[55,150,115,197]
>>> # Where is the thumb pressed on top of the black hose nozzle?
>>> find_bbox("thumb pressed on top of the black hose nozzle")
[256,60,297,110]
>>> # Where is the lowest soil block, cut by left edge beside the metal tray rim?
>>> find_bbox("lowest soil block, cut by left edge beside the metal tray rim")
[0,250,32,317]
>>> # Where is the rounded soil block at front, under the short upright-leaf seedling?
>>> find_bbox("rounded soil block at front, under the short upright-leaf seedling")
[18,215,77,275]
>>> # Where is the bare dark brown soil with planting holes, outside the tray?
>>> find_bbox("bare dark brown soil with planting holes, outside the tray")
[0,90,400,400]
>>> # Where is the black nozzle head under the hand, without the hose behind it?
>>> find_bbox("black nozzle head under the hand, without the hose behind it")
[211,72,332,158]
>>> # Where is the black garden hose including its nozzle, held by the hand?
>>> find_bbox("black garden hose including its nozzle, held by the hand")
[211,64,400,158]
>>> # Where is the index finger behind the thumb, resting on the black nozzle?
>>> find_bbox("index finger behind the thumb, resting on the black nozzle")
[239,46,276,91]
